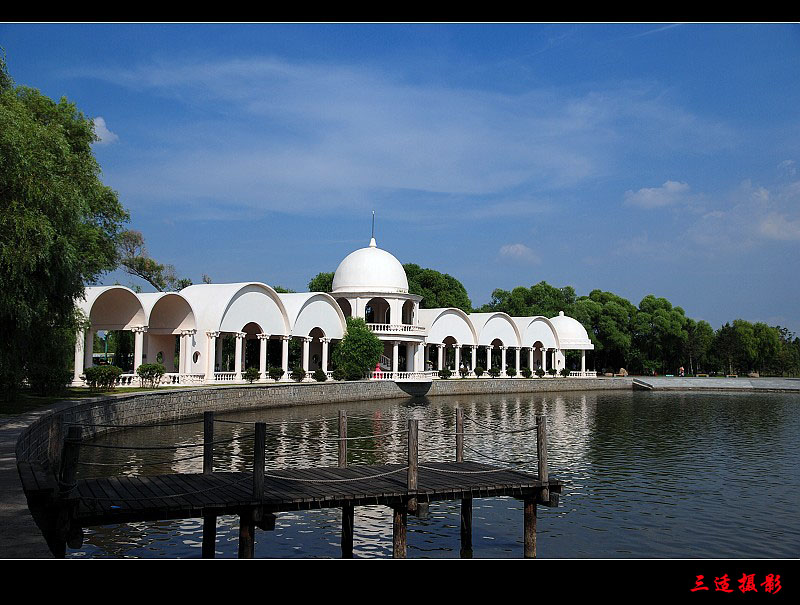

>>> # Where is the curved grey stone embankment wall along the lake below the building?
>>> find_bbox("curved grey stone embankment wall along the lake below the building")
[16,378,632,468]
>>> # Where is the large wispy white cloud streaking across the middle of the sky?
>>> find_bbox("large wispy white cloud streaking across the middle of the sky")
[71,58,730,219]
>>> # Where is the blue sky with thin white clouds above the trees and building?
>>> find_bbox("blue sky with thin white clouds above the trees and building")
[0,23,800,333]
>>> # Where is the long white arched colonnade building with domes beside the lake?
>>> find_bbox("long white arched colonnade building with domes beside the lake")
[74,238,594,384]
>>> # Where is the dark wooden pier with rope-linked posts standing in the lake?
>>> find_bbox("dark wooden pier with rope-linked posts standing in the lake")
[20,409,562,558]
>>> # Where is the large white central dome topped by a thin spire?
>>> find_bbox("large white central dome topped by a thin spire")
[333,237,408,294]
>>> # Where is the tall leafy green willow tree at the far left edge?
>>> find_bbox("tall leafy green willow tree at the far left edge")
[0,57,128,399]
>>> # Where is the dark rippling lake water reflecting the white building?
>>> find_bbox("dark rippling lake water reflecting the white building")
[69,392,800,558]
